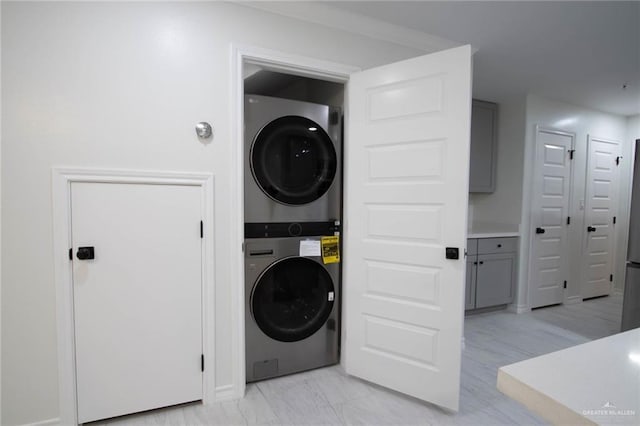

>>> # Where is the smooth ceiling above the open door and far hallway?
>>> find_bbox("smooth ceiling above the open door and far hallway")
[325,1,640,116]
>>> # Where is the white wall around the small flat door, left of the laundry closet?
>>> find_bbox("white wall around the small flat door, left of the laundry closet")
[2,2,430,425]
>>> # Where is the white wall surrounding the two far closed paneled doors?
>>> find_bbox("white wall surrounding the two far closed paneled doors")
[517,95,630,308]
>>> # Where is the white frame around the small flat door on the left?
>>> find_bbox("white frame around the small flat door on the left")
[52,167,215,424]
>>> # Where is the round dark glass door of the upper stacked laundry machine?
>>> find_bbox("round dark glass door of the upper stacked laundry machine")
[251,115,337,204]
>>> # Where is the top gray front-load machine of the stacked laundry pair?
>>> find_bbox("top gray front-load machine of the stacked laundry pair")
[244,95,342,225]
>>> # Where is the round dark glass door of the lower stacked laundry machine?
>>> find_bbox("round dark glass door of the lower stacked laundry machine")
[251,257,334,342]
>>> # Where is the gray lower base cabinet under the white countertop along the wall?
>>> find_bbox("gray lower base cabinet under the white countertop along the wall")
[465,237,518,310]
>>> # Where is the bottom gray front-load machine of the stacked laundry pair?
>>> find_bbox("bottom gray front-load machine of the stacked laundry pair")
[245,233,340,382]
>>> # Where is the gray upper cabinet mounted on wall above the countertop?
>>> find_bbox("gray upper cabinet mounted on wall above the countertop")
[469,99,498,192]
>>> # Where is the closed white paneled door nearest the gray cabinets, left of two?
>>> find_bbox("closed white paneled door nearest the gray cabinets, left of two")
[529,128,575,308]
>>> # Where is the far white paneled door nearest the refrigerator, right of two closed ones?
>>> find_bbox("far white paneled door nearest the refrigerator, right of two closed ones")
[581,137,620,299]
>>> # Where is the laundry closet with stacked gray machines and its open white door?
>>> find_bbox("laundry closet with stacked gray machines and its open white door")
[236,46,471,410]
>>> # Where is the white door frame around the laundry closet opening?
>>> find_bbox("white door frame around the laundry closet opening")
[229,44,360,398]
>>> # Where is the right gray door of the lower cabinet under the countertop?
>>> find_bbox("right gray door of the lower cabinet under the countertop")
[476,253,516,308]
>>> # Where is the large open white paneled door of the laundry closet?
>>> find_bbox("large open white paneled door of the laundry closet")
[343,46,471,410]
